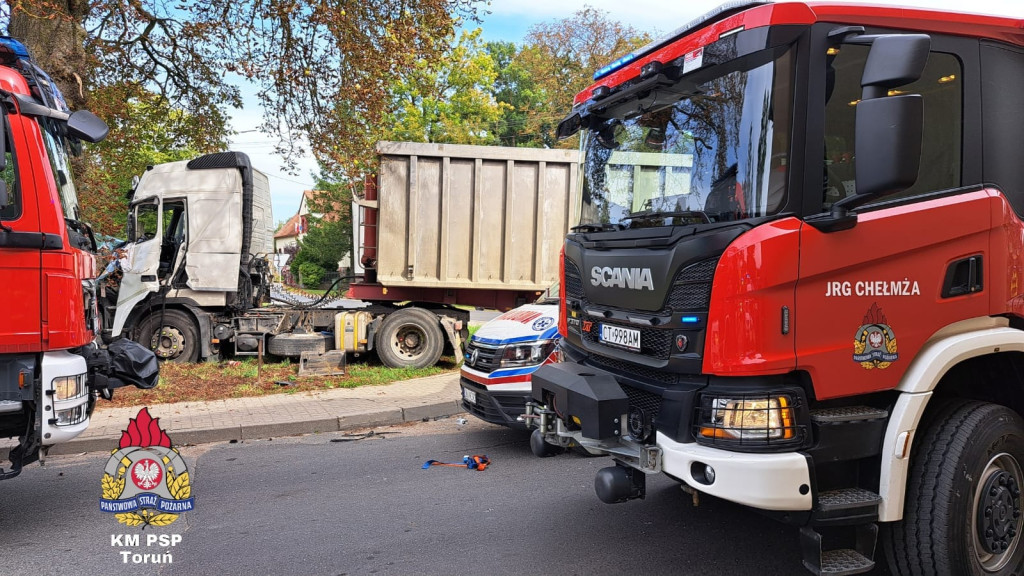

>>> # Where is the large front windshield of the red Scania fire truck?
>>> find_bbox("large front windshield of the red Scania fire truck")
[581,50,794,228]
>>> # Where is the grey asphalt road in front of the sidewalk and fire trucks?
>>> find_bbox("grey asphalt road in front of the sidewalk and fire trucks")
[0,418,881,576]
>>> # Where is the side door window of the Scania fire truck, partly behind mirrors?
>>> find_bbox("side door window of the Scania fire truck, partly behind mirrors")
[822,44,963,210]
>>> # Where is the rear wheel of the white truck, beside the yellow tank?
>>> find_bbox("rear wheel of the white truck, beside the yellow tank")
[375,307,444,368]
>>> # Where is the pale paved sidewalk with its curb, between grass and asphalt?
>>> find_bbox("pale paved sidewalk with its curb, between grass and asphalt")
[50,372,463,454]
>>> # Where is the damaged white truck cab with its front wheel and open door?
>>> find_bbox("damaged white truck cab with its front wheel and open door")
[106,152,273,361]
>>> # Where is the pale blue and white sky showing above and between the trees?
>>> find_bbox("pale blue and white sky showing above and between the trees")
[231,0,1024,221]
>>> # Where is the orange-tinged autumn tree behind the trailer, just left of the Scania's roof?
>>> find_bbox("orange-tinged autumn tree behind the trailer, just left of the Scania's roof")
[516,6,650,148]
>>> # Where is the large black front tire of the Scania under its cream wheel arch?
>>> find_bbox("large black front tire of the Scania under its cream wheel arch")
[883,402,1024,576]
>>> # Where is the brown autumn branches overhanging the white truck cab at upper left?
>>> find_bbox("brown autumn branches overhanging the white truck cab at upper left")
[0,0,475,225]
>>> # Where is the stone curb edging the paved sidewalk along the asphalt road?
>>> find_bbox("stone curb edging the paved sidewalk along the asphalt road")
[49,401,464,456]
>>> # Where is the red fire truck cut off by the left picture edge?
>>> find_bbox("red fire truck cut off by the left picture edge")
[0,37,158,480]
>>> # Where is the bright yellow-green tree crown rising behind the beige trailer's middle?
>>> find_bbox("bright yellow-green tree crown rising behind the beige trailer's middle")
[384,29,507,145]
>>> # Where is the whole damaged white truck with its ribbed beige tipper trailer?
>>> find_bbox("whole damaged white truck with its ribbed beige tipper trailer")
[104,141,577,367]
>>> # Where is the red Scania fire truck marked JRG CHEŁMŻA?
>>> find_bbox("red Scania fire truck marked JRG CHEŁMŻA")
[526,1,1024,575]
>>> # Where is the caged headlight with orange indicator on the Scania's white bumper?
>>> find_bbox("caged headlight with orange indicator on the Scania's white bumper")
[697,395,797,444]
